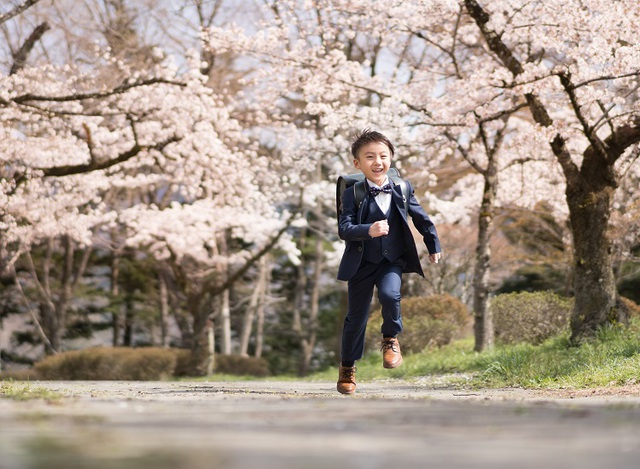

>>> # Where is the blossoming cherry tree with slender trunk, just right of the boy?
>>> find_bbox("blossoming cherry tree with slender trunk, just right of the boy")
[204,2,560,348]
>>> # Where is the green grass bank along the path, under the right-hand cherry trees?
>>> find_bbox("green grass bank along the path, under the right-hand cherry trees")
[310,321,640,389]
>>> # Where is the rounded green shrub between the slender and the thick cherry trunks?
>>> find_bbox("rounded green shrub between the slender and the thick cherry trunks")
[491,291,573,345]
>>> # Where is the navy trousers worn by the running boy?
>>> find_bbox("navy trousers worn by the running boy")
[341,259,402,361]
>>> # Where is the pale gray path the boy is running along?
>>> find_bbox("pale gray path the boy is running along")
[0,381,640,469]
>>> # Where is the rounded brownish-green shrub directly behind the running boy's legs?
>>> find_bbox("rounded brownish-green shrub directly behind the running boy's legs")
[366,295,470,353]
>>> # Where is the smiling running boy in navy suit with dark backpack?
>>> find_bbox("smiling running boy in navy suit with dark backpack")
[337,129,440,394]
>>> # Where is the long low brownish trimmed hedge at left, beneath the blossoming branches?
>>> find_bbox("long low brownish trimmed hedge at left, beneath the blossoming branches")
[34,347,177,381]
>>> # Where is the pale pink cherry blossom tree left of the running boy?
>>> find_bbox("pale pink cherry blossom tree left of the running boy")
[0,0,295,366]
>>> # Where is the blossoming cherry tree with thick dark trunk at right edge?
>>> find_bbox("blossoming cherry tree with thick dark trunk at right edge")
[464,0,640,341]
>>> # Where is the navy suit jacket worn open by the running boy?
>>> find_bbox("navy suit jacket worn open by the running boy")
[338,181,440,280]
